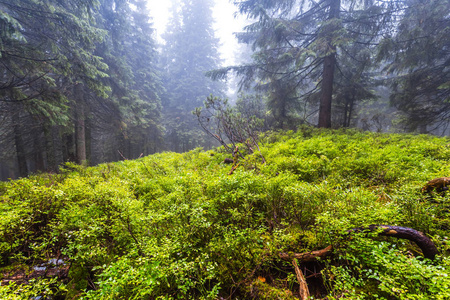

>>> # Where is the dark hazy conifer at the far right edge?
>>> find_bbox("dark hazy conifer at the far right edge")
[379,0,450,134]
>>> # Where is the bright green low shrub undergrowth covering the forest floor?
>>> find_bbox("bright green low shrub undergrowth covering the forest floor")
[0,128,450,299]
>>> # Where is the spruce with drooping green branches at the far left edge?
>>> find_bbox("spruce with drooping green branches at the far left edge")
[0,0,106,176]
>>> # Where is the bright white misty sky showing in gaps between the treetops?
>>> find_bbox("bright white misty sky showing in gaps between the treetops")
[148,0,244,65]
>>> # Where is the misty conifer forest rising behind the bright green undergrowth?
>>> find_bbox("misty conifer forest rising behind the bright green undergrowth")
[0,0,450,180]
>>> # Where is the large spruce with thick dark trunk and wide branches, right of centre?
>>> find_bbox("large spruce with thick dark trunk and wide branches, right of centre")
[210,0,395,127]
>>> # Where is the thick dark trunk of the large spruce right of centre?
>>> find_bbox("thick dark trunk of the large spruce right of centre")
[318,0,341,128]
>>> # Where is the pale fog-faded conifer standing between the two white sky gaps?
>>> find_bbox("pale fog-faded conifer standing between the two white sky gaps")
[162,0,223,151]
